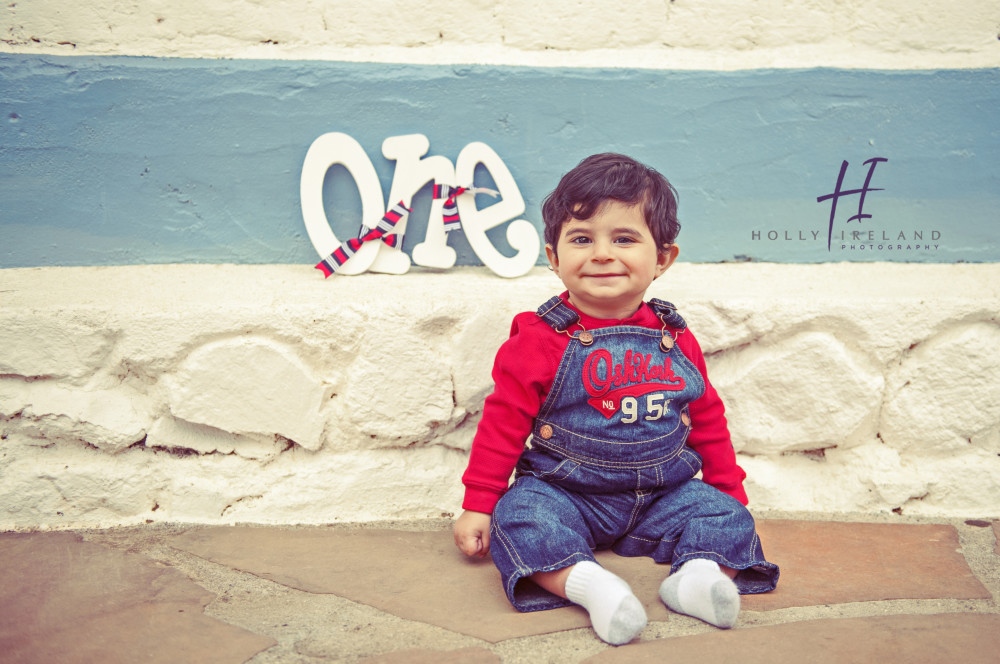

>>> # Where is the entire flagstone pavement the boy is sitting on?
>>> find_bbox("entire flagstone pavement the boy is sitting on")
[0,513,1000,664]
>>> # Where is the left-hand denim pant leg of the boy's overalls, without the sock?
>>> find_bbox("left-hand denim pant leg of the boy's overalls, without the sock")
[490,476,594,611]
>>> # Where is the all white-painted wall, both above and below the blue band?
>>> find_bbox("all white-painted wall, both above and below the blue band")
[0,0,1000,528]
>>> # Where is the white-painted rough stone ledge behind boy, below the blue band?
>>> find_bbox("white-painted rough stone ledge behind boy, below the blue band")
[0,263,1000,528]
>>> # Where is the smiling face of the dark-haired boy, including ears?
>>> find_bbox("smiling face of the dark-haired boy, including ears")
[545,200,677,319]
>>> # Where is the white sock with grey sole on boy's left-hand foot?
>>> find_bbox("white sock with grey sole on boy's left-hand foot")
[566,560,646,646]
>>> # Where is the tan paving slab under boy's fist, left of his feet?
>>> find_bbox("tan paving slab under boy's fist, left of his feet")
[170,527,590,643]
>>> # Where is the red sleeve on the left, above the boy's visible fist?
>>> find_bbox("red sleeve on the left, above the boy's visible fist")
[462,313,569,514]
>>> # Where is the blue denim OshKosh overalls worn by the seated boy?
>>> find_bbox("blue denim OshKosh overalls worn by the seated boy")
[490,297,778,611]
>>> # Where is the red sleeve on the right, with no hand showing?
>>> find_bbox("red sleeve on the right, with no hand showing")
[677,330,748,505]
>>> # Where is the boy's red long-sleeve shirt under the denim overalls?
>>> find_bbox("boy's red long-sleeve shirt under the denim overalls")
[462,293,747,514]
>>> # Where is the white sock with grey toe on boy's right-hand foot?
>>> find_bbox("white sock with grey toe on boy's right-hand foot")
[660,558,740,629]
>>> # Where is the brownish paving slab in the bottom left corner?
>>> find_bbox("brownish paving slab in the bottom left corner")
[0,532,275,664]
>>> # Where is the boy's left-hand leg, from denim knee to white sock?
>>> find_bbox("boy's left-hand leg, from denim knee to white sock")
[490,477,646,645]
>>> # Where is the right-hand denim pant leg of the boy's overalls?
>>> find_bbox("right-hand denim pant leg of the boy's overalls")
[613,479,779,594]
